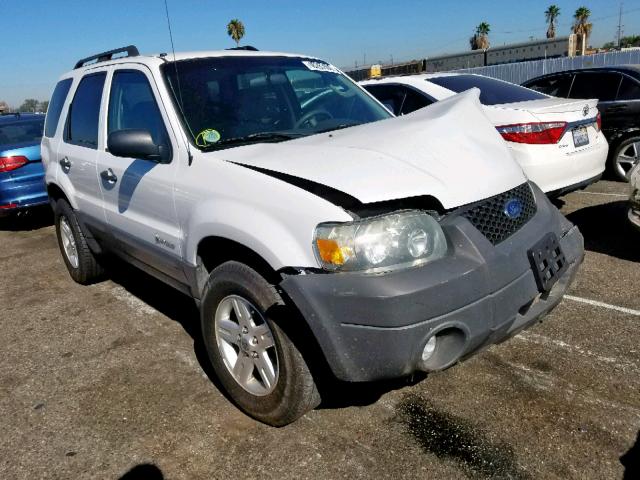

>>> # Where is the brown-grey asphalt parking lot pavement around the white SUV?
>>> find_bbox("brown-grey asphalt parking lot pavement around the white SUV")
[0,181,640,480]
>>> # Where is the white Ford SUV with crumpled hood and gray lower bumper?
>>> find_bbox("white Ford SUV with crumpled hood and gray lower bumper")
[42,47,583,425]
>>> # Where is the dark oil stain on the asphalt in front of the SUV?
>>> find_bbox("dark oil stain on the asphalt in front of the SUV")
[396,395,530,480]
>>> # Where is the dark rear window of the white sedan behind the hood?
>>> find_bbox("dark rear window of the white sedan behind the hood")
[427,75,549,105]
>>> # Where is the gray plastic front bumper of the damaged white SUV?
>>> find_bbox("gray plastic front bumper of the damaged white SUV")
[281,187,584,381]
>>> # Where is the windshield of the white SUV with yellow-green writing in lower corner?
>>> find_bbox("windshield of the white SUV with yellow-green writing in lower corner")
[163,56,391,150]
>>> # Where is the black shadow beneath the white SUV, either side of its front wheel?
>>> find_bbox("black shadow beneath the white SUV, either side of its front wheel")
[107,257,410,409]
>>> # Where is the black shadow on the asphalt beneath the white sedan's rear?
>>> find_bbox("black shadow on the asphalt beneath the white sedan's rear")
[567,201,640,262]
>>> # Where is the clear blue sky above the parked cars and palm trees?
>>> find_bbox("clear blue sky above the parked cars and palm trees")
[0,0,640,107]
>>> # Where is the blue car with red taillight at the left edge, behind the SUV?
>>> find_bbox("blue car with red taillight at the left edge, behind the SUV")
[0,113,48,216]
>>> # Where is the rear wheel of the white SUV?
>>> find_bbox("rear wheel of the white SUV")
[54,200,104,285]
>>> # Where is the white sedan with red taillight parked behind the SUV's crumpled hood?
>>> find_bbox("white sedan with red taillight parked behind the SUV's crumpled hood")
[361,73,609,196]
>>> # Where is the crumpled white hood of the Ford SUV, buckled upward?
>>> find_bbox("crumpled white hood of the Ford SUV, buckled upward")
[216,89,526,209]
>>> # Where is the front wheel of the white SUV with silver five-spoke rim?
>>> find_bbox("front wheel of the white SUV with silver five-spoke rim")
[200,261,320,427]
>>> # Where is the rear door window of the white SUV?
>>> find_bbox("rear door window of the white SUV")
[65,72,107,149]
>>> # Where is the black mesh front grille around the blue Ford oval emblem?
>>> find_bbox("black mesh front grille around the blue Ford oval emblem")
[462,183,536,245]
